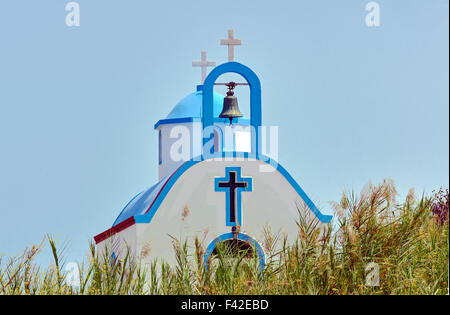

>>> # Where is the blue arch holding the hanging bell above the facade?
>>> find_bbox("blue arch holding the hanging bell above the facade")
[202,61,262,155]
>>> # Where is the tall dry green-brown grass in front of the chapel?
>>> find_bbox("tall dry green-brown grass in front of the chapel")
[0,180,449,294]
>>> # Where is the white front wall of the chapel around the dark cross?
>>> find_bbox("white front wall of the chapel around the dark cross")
[98,159,325,263]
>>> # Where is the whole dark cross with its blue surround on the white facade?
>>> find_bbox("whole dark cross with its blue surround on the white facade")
[214,167,252,226]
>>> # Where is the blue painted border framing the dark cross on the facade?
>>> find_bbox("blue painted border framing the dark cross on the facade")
[214,167,253,226]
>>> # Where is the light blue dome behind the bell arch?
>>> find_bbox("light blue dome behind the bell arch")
[166,90,224,119]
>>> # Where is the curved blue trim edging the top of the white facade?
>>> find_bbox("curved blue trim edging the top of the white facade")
[134,152,333,223]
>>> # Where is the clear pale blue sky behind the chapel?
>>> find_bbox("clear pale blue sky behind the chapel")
[0,0,449,262]
